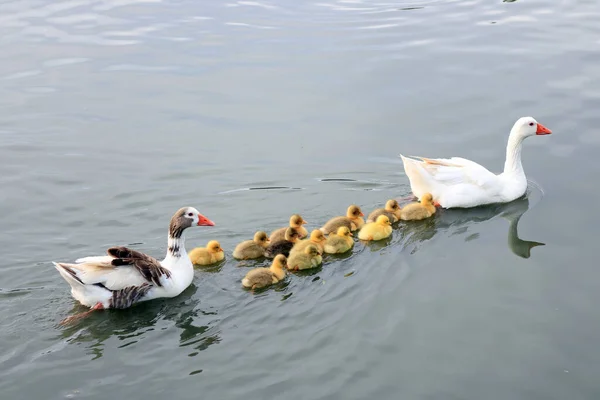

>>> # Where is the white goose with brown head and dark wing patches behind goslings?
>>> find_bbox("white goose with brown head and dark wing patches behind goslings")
[53,207,215,323]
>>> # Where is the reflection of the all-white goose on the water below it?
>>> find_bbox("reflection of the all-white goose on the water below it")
[400,197,545,258]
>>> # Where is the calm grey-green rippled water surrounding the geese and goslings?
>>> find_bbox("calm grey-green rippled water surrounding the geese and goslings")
[0,0,600,400]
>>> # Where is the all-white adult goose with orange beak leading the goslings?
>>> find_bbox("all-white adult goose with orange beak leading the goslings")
[400,117,552,208]
